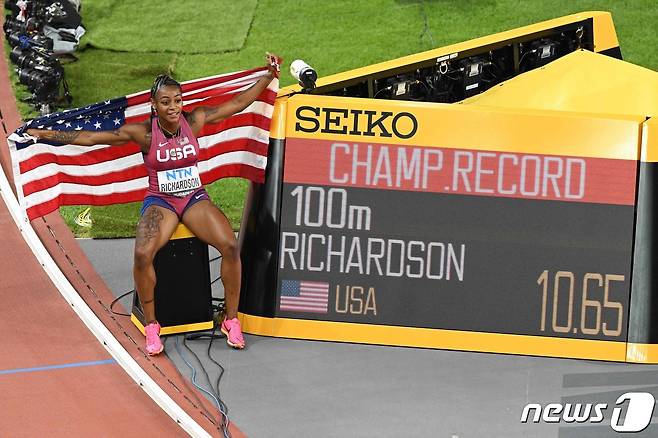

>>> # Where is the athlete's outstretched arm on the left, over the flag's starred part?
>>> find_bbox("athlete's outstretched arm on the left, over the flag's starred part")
[27,123,148,146]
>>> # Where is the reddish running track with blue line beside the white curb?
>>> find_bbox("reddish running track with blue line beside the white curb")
[0,11,244,438]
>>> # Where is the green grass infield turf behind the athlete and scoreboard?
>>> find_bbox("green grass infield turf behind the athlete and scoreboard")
[5,0,658,237]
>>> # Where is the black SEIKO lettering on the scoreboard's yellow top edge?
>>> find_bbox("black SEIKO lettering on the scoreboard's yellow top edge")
[295,106,418,139]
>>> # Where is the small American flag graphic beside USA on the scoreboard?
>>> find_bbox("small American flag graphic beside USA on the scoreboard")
[279,280,329,313]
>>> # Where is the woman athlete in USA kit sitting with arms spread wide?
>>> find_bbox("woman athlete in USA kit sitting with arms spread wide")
[27,54,281,355]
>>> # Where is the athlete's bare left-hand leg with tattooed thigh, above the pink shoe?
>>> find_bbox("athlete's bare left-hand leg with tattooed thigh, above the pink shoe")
[133,205,178,324]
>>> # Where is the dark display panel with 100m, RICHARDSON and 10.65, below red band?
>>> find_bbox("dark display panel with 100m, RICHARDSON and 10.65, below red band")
[277,183,634,340]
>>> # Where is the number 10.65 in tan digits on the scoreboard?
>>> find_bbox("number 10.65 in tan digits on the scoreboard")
[537,270,625,336]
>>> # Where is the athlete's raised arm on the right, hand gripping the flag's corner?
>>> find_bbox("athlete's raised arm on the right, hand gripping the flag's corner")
[187,53,282,135]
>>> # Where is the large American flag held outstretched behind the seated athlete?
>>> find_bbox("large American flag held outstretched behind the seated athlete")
[7,67,279,220]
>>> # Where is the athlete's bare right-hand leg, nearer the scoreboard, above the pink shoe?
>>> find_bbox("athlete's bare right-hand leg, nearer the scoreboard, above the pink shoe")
[183,200,242,319]
